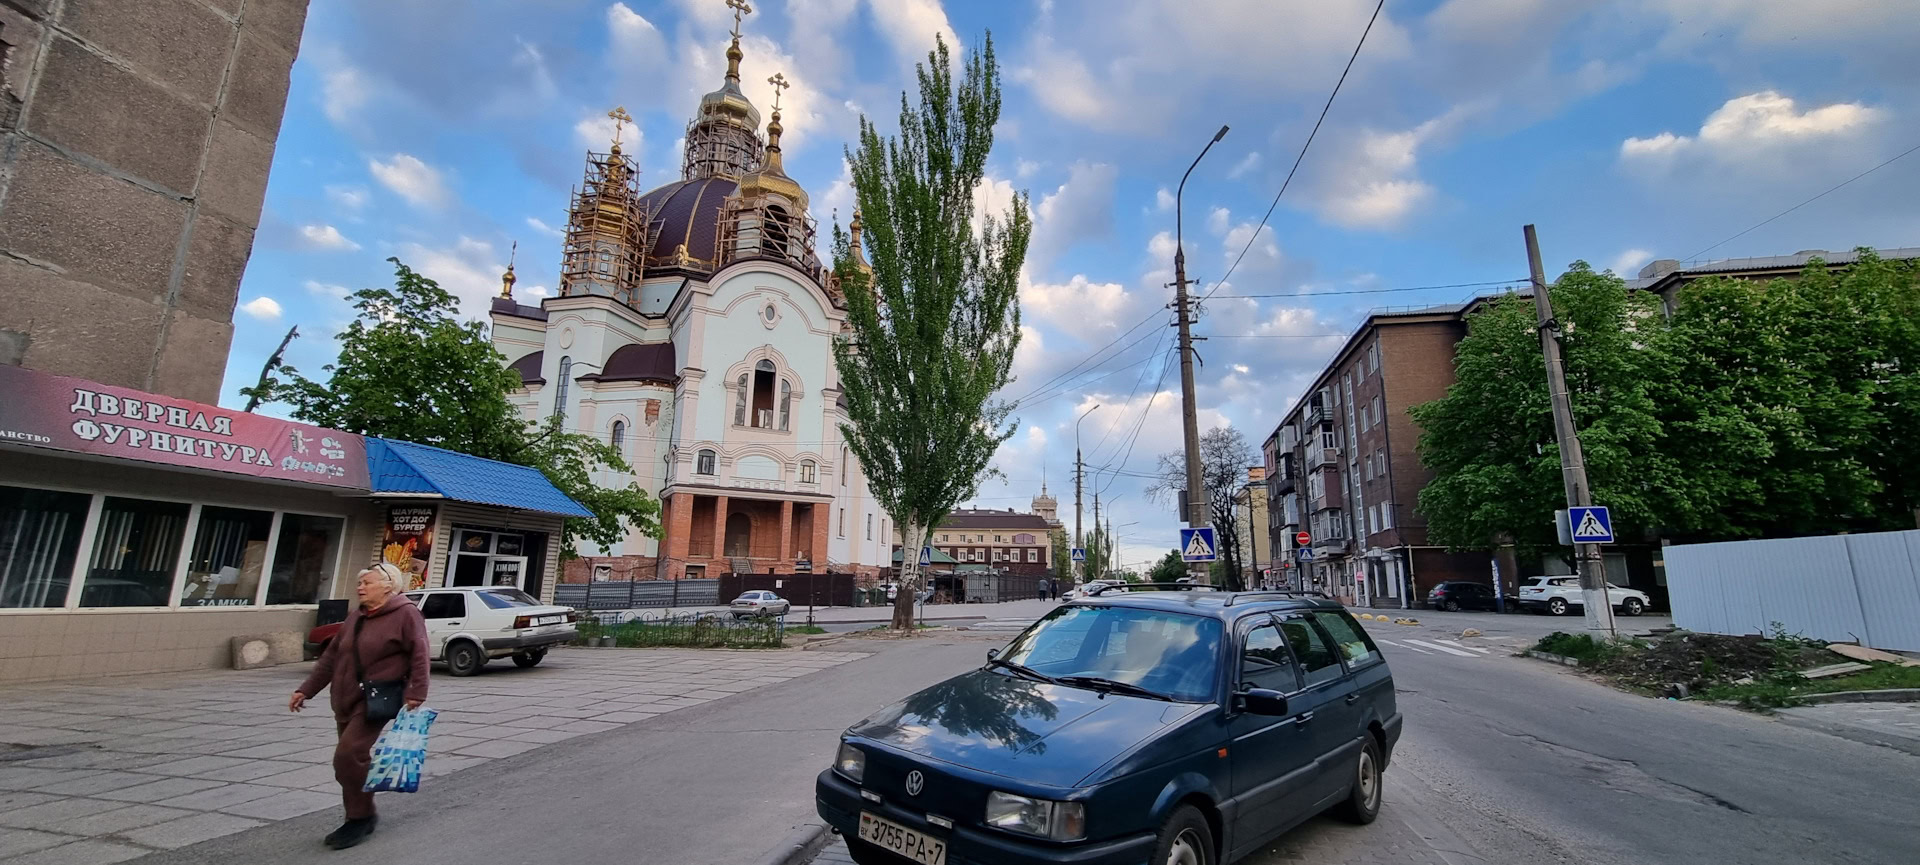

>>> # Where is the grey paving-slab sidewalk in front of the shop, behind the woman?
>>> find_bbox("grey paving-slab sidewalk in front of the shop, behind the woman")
[0,648,864,865]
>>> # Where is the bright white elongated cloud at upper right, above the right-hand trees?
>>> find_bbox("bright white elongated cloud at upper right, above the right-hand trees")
[1620,90,1885,161]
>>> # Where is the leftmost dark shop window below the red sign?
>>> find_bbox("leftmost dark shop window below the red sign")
[0,487,92,608]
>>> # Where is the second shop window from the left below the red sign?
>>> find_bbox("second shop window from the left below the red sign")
[81,497,190,606]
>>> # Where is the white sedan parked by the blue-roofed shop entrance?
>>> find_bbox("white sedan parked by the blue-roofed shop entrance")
[407,585,580,675]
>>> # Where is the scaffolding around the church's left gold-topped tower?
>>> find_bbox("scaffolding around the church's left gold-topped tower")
[561,142,651,305]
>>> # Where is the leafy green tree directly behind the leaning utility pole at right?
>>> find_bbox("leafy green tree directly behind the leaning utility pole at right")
[1413,261,1678,558]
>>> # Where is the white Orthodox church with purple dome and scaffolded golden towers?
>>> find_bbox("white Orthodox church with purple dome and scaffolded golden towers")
[492,4,895,579]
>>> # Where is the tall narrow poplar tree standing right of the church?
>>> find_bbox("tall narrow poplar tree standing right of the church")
[833,35,1033,627]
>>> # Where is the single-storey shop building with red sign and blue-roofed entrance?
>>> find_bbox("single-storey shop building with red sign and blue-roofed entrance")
[0,366,588,683]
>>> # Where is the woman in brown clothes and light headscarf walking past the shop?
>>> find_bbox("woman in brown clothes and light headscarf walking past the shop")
[286,562,428,850]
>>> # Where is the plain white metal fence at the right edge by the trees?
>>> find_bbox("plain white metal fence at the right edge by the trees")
[1667,531,1920,650]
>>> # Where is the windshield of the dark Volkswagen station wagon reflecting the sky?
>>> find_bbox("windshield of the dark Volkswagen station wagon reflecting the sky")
[1000,606,1221,702]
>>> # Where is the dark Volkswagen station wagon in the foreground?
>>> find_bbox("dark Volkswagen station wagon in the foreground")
[814,583,1402,865]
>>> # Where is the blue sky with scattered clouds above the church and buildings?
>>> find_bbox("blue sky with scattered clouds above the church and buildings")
[225,0,1920,562]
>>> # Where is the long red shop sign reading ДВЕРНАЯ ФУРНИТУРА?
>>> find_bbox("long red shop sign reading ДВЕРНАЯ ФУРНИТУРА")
[0,366,367,489]
